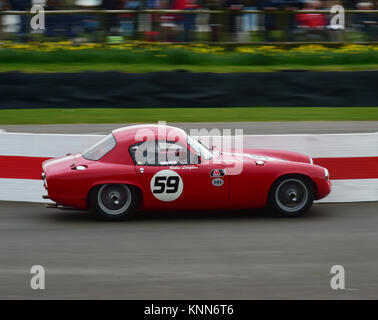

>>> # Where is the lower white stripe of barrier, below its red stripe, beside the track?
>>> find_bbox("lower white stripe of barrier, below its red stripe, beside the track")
[0,179,378,203]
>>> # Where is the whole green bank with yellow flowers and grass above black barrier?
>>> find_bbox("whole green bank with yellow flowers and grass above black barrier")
[0,43,378,72]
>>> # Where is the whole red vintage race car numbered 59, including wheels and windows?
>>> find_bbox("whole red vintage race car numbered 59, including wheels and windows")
[42,125,331,220]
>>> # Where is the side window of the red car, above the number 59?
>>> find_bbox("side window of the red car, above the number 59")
[129,141,195,166]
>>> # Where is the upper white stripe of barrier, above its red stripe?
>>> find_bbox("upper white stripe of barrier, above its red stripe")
[0,133,378,158]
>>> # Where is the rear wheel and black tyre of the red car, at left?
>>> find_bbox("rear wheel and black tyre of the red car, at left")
[88,184,140,220]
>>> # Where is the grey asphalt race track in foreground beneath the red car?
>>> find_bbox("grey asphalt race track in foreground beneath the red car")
[0,202,378,299]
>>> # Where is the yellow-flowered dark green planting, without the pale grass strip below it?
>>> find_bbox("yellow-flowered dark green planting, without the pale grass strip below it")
[0,44,378,66]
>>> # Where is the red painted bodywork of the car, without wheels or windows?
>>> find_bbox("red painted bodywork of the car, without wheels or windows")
[43,125,331,216]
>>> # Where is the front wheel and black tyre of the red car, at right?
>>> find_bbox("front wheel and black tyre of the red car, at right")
[269,176,315,217]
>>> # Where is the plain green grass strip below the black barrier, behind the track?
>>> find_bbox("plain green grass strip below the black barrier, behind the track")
[0,107,378,125]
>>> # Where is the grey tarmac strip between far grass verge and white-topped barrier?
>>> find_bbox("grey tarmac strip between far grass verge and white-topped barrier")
[0,121,378,134]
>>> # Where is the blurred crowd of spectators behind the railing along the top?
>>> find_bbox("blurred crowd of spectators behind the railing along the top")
[0,0,378,43]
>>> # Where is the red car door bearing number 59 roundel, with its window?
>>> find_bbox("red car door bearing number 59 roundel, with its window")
[130,141,230,209]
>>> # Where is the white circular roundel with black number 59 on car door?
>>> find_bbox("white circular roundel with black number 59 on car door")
[150,170,184,202]
